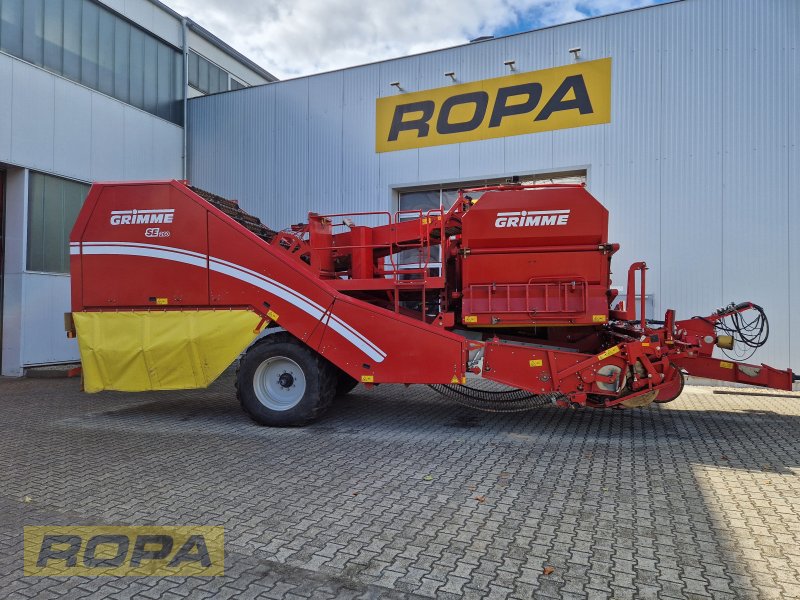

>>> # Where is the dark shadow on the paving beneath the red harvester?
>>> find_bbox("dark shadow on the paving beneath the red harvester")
[96,377,800,473]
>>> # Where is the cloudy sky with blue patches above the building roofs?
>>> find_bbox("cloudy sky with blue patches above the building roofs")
[166,0,665,79]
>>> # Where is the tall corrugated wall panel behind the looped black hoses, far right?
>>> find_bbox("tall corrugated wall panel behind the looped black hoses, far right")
[720,0,797,364]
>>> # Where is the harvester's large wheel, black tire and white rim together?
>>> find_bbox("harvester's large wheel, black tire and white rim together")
[236,333,337,427]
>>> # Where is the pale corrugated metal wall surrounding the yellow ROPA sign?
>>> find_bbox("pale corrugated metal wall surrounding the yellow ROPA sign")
[188,0,800,370]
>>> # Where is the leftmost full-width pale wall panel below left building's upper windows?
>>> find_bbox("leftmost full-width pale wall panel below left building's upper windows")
[11,60,55,171]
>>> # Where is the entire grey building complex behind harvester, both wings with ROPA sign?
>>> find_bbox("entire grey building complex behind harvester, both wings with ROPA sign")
[0,0,800,375]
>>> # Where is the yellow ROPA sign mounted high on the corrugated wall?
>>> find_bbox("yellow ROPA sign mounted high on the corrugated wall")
[375,58,611,152]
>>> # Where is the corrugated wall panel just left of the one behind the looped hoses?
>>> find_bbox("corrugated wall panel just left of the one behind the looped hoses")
[657,2,725,324]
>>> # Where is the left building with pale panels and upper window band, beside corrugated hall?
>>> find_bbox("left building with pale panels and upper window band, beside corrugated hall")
[0,0,275,375]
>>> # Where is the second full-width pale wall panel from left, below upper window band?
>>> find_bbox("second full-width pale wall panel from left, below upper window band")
[53,77,92,179]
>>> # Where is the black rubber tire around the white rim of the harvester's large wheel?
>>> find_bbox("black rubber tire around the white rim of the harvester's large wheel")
[236,332,338,427]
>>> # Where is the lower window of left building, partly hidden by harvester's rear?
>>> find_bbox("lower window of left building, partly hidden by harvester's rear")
[27,171,90,273]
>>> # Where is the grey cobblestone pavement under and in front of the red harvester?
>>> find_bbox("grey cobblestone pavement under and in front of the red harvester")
[0,375,800,600]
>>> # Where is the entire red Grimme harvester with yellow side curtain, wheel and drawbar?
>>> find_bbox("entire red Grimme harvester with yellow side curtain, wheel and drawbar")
[68,181,796,425]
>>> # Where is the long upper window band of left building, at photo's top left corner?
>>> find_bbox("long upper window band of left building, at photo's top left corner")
[0,0,183,125]
